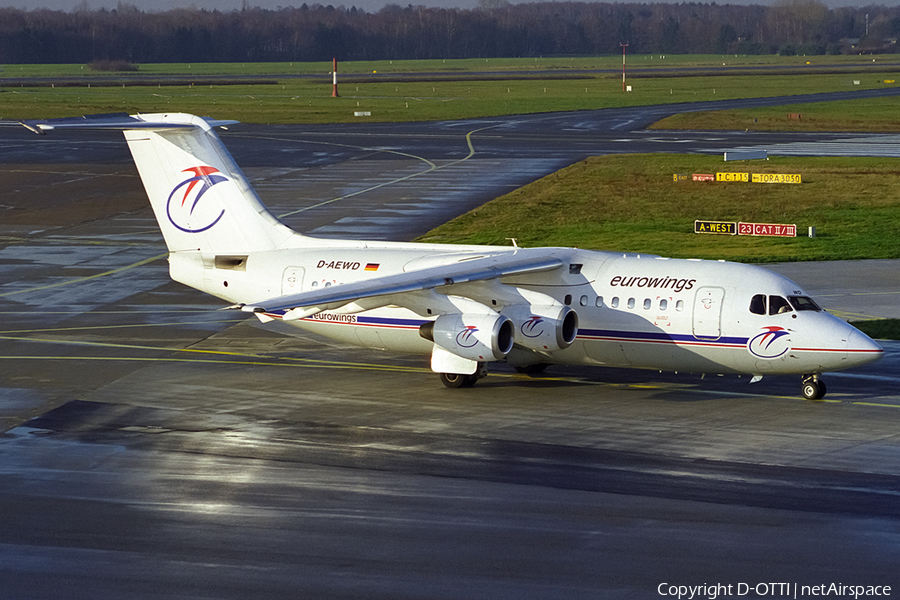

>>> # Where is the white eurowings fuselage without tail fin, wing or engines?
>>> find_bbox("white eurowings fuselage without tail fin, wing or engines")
[171,238,881,375]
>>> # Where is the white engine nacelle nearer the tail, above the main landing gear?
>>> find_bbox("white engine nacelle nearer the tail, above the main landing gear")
[419,313,515,362]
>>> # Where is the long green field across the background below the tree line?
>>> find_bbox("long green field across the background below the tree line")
[0,55,900,124]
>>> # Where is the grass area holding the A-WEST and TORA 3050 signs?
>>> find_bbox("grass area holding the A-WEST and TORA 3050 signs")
[420,154,900,263]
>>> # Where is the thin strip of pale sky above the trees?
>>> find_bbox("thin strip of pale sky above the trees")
[0,0,900,12]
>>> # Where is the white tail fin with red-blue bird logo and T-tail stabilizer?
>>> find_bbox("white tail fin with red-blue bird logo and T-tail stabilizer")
[23,113,298,253]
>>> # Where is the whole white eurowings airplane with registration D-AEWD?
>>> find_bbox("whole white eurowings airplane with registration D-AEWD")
[22,113,884,399]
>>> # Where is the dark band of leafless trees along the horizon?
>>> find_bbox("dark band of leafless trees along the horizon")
[0,0,900,64]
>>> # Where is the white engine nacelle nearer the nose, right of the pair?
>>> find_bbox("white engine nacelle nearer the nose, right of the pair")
[502,304,578,352]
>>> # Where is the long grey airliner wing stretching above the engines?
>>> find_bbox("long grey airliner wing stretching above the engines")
[240,249,563,318]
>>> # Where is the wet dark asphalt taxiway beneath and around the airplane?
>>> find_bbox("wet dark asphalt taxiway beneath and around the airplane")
[0,96,900,599]
